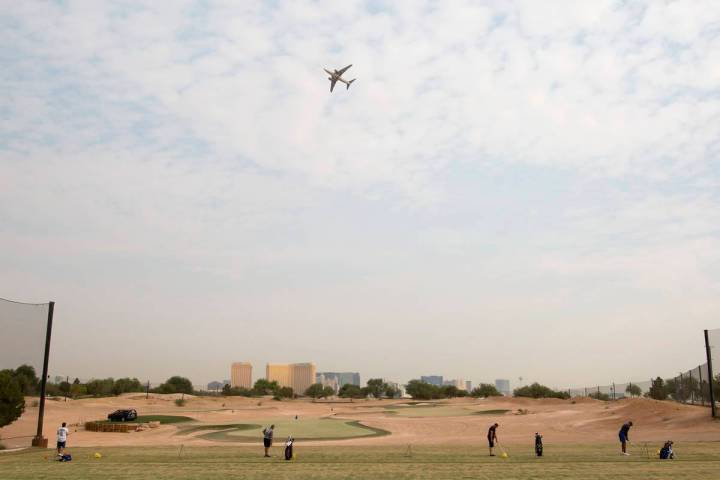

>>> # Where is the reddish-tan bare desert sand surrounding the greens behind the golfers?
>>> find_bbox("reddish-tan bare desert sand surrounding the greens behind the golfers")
[0,394,720,446]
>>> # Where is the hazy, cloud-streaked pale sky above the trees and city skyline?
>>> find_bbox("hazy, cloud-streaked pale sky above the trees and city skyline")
[0,0,720,387]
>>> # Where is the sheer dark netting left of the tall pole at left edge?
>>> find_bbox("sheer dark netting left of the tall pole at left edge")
[0,299,49,448]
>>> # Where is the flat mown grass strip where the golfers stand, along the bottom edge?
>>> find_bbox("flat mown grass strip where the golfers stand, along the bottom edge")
[0,442,720,480]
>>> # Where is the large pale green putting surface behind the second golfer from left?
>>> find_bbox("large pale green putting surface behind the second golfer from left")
[183,418,390,442]
